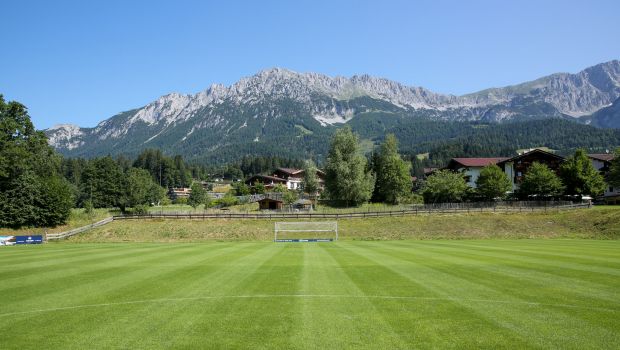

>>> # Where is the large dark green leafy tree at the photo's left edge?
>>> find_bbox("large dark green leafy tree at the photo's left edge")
[0,95,73,228]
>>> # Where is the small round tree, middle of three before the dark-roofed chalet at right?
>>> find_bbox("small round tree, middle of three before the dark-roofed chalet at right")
[519,162,564,198]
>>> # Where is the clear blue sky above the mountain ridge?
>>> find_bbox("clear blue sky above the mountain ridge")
[0,0,620,128]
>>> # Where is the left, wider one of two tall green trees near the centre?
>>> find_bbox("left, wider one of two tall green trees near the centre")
[325,126,375,206]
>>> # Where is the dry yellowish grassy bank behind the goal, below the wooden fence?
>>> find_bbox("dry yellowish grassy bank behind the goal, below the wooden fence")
[64,207,620,242]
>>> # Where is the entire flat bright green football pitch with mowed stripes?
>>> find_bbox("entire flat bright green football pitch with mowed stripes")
[0,239,620,349]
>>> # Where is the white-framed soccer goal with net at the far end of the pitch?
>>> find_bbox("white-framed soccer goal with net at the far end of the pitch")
[273,221,338,242]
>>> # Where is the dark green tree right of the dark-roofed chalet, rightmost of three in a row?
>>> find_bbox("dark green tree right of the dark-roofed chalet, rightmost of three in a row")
[560,149,605,196]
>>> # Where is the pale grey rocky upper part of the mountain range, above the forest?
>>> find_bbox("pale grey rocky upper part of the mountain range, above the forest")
[46,60,620,159]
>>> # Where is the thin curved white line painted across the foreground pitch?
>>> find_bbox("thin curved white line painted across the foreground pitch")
[0,294,620,317]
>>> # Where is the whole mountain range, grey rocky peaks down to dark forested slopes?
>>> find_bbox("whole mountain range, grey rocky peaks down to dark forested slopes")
[45,60,620,162]
